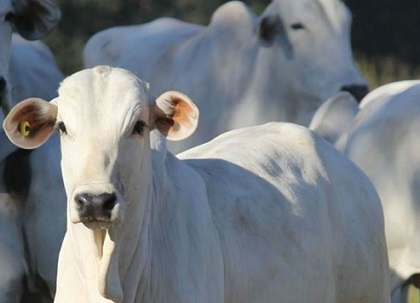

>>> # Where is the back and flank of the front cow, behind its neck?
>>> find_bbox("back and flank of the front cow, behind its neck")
[179,124,389,302]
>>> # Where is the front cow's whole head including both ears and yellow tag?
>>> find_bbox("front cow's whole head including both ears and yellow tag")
[3,66,198,228]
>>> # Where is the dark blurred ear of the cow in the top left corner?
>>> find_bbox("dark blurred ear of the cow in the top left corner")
[8,0,61,40]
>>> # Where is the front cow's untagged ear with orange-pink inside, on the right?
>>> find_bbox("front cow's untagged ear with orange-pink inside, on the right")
[151,91,199,141]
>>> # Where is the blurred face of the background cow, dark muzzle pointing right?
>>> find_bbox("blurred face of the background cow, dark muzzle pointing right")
[257,0,367,106]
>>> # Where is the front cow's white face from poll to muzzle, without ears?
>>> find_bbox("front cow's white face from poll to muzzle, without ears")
[54,67,154,227]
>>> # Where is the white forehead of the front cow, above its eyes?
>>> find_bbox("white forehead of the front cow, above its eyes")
[56,66,149,127]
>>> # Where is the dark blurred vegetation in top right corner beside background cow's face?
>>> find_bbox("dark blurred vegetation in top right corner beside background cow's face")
[344,0,420,88]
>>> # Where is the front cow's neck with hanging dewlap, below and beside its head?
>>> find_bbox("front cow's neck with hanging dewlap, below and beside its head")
[66,134,179,302]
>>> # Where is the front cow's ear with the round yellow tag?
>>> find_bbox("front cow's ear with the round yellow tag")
[3,98,57,149]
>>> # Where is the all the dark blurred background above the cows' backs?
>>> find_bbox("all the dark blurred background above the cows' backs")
[44,0,420,88]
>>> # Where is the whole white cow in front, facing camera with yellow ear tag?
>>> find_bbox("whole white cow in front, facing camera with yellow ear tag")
[4,66,389,303]
